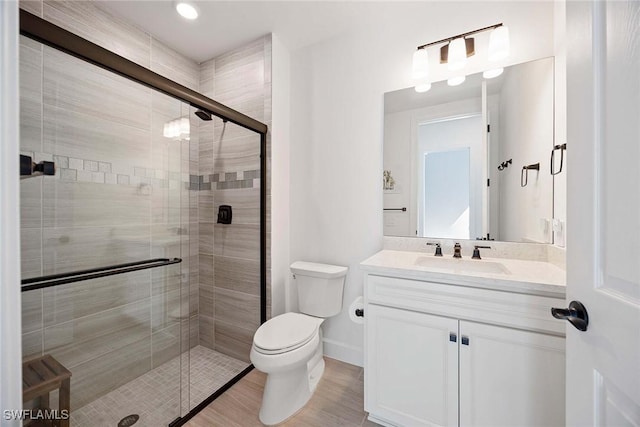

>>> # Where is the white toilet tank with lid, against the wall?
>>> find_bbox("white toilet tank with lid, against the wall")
[291,261,348,317]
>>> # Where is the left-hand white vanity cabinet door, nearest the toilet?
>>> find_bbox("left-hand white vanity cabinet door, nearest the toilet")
[365,304,458,427]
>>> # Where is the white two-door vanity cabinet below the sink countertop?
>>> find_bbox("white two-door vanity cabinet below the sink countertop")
[364,272,565,427]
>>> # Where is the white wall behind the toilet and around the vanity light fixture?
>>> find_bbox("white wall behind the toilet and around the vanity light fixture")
[291,1,553,364]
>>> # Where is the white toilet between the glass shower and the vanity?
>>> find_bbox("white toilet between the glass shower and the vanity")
[250,261,348,425]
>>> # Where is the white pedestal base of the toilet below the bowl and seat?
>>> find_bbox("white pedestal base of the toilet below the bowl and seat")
[259,335,324,426]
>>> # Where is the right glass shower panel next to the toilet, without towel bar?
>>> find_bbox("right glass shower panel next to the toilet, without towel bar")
[189,106,262,409]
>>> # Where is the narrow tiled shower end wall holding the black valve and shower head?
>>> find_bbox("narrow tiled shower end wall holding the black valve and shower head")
[198,35,271,361]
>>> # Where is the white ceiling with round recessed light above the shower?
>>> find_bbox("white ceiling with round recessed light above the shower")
[96,0,401,62]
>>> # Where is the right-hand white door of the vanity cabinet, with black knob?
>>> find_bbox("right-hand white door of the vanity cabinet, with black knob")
[460,321,565,427]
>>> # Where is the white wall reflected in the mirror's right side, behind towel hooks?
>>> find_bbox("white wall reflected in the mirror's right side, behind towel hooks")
[499,58,553,243]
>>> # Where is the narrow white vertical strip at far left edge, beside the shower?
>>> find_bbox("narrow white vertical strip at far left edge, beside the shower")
[0,1,22,427]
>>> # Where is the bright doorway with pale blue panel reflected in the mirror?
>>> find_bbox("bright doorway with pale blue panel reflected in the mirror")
[416,115,483,239]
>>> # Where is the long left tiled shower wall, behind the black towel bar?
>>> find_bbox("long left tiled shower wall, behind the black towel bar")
[20,1,200,408]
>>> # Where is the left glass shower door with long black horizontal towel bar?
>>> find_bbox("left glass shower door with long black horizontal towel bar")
[20,37,194,427]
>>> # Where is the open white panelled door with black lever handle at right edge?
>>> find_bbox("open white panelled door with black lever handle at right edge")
[566,0,640,427]
